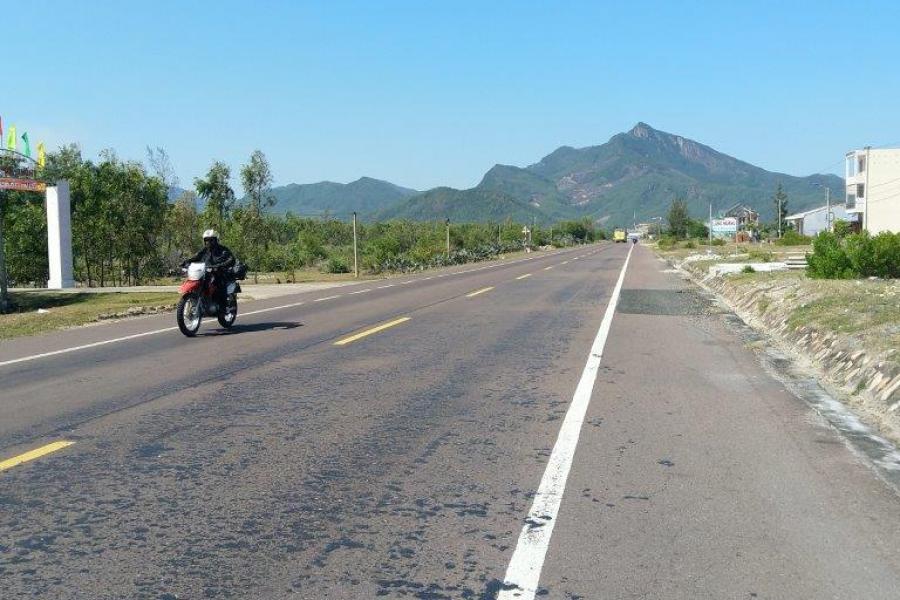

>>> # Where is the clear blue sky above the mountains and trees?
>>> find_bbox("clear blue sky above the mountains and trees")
[0,0,900,189]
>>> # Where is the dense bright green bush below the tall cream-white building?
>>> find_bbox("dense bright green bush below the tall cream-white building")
[806,231,900,279]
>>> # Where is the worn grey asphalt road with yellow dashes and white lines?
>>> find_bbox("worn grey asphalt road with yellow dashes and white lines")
[0,244,900,600]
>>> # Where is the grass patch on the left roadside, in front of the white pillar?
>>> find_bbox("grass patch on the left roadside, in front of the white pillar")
[0,292,178,339]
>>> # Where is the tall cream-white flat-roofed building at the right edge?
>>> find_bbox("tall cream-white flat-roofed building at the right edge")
[846,148,900,235]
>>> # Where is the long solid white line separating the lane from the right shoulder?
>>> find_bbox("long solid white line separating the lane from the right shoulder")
[497,246,634,600]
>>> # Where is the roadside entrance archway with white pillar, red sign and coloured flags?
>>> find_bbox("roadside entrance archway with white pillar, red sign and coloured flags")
[0,149,75,309]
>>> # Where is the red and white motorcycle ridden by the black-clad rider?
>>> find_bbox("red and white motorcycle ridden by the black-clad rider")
[175,263,241,337]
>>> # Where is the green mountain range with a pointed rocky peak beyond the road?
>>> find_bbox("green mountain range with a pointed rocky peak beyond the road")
[273,123,844,226]
